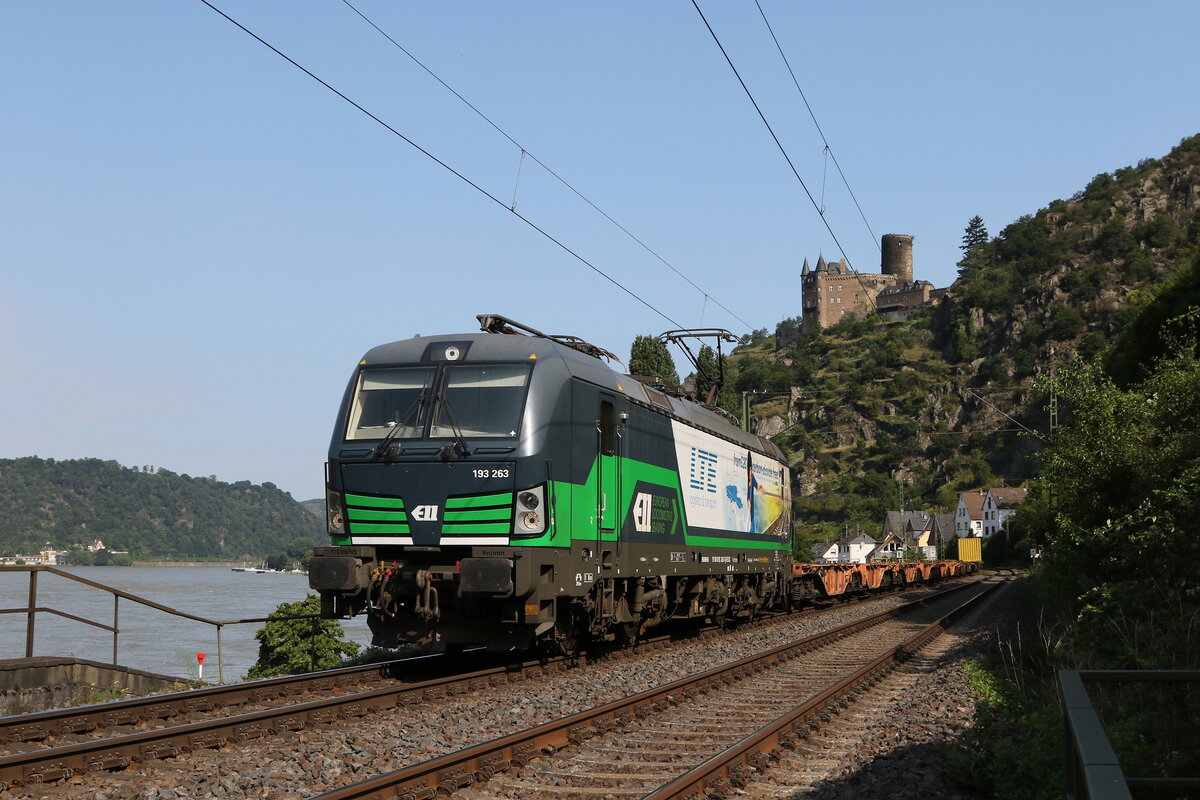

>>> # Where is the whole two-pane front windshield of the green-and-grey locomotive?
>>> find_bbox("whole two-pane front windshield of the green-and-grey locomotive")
[346,363,529,439]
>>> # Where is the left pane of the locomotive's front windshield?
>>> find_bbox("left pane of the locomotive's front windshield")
[346,367,433,439]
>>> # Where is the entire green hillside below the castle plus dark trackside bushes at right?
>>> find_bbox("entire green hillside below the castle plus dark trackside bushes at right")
[638,136,1200,798]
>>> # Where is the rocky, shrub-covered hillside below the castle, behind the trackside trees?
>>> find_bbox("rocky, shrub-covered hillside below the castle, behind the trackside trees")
[685,136,1200,559]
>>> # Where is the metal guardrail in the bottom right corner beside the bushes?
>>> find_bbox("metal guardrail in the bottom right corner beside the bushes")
[1058,669,1200,800]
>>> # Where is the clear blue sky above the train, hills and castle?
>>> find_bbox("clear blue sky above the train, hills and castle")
[0,0,1200,499]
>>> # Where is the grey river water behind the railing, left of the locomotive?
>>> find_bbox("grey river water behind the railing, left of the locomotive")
[0,566,371,682]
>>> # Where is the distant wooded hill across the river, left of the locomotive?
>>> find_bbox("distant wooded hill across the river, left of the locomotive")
[0,457,325,559]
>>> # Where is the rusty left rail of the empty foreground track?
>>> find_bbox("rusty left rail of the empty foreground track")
[304,582,978,800]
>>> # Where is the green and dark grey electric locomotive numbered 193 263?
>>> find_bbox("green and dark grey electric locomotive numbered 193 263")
[308,315,792,651]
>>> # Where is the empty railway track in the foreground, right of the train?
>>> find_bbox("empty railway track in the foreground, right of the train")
[304,582,1000,800]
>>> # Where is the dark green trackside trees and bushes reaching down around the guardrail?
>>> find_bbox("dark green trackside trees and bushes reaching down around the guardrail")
[960,247,1200,800]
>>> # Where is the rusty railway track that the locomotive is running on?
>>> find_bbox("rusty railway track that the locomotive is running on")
[0,575,979,790]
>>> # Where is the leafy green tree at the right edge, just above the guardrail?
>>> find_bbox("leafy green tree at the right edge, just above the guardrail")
[1030,336,1200,669]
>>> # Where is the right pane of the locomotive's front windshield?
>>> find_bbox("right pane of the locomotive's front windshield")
[430,363,529,437]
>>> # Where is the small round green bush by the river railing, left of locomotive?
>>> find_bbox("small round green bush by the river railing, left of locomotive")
[246,595,360,679]
